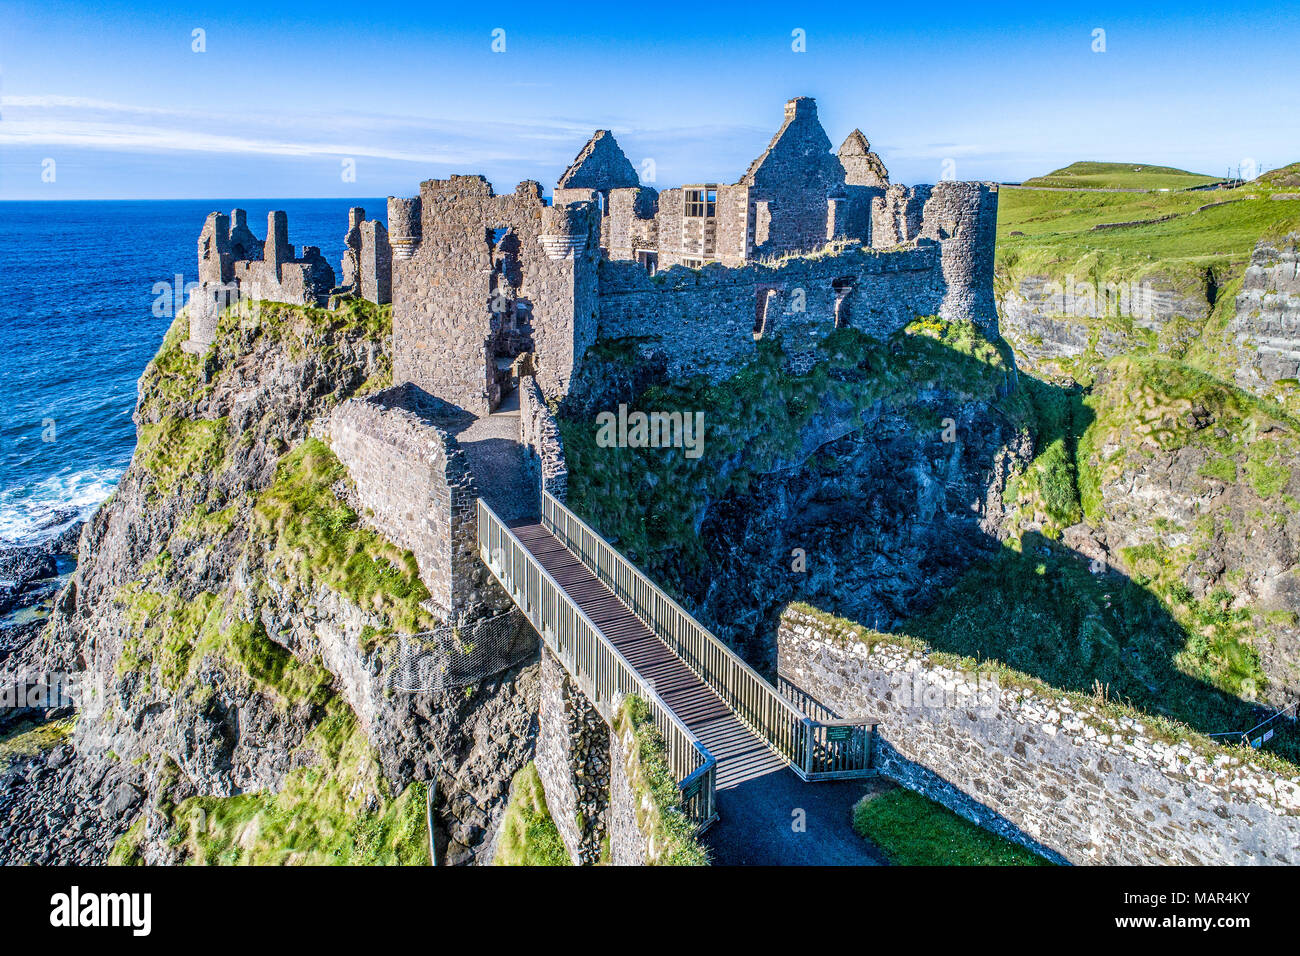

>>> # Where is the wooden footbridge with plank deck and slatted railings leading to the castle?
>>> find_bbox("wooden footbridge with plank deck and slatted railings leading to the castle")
[478,492,874,829]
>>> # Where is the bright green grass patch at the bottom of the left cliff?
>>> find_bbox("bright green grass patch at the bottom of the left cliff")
[160,700,429,866]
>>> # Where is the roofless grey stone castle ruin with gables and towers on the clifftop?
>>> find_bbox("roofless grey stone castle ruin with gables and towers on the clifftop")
[190,96,997,416]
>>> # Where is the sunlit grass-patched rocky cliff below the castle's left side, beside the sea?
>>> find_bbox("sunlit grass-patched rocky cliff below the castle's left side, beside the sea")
[4,303,537,862]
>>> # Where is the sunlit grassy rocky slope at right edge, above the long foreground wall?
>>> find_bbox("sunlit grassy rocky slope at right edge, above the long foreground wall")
[1079,358,1300,705]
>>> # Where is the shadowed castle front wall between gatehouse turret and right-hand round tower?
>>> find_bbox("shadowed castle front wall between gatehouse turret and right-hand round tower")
[599,241,944,381]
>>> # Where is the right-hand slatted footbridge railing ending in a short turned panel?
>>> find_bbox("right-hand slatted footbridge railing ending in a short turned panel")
[542,492,874,780]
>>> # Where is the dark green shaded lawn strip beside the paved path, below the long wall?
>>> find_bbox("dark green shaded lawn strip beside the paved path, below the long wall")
[853,788,1050,866]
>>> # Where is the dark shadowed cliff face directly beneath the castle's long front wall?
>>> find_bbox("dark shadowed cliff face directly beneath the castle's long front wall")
[562,320,1034,666]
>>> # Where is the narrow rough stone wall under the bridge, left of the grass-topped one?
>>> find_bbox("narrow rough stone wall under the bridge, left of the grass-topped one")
[534,644,610,866]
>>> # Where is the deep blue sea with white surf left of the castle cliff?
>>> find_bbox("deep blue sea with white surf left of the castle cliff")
[0,199,385,545]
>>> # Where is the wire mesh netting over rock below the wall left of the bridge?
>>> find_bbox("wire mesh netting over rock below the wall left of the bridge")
[385,610,537,693]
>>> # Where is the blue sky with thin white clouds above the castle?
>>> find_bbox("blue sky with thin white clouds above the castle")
[0,0,1300,199]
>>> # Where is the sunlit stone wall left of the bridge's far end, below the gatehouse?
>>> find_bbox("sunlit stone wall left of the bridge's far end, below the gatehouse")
[322,385,478,619]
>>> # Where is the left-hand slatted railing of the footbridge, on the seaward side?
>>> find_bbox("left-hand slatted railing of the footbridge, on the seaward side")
[477,498,718,829]
